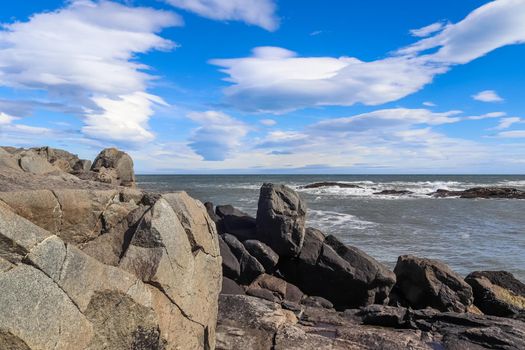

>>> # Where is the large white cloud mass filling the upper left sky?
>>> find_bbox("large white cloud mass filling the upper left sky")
[0,0,182,141]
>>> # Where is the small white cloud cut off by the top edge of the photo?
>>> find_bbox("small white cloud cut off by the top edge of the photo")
[166,0,279,31]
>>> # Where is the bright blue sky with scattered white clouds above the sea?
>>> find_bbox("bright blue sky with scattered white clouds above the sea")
[0,0,525,174]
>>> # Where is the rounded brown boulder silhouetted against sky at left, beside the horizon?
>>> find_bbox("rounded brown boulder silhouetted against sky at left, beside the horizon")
[91,148,135,187]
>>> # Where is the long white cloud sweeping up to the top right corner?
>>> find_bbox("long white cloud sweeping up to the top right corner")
[211,0,525,113]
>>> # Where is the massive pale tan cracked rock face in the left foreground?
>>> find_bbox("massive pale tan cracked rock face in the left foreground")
[0,189,221,350]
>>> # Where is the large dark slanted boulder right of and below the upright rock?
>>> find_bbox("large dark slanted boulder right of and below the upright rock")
[279,228,395,309]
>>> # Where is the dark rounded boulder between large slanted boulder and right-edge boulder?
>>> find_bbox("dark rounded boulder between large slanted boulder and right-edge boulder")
[394,255,473,312]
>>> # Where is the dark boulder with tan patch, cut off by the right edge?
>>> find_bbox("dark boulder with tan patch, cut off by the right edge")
[465,271,525,320]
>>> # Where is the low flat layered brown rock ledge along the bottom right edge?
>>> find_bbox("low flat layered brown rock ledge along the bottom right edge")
[217,295,525,350]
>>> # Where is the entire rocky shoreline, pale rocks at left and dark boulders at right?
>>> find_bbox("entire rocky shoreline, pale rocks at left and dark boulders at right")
[0,147,525,350]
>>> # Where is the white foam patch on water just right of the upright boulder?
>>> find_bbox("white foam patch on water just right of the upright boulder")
[307,209,378,233]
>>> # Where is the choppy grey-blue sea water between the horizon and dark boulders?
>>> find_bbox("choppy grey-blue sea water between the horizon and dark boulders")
[138,175,525,281]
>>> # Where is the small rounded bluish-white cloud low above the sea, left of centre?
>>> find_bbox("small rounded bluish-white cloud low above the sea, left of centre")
[188,111,250,161]
